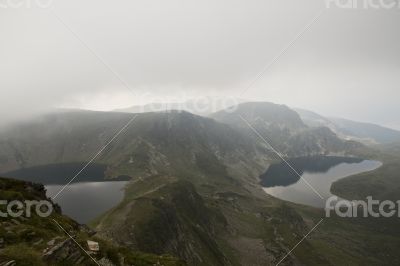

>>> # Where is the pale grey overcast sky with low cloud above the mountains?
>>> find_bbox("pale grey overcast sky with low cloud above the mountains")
[0,0,400,129]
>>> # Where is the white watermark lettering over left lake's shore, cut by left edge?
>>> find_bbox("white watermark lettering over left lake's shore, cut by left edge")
[0,200,53,218]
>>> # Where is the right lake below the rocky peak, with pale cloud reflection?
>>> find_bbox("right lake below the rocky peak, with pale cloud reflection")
[260,156,382,208]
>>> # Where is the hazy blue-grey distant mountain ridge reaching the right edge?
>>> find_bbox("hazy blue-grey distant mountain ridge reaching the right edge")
[296,109,400,144]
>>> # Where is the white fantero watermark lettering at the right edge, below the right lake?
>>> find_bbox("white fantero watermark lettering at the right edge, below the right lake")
[325,196,400,218]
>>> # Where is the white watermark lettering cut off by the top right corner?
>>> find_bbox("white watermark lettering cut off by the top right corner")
[325,0,400,9]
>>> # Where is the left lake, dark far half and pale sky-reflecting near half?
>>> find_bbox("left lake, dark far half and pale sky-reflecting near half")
[1,163,130,223]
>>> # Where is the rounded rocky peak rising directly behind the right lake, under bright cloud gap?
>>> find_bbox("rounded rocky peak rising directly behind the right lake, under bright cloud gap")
[210,102,364,157]
